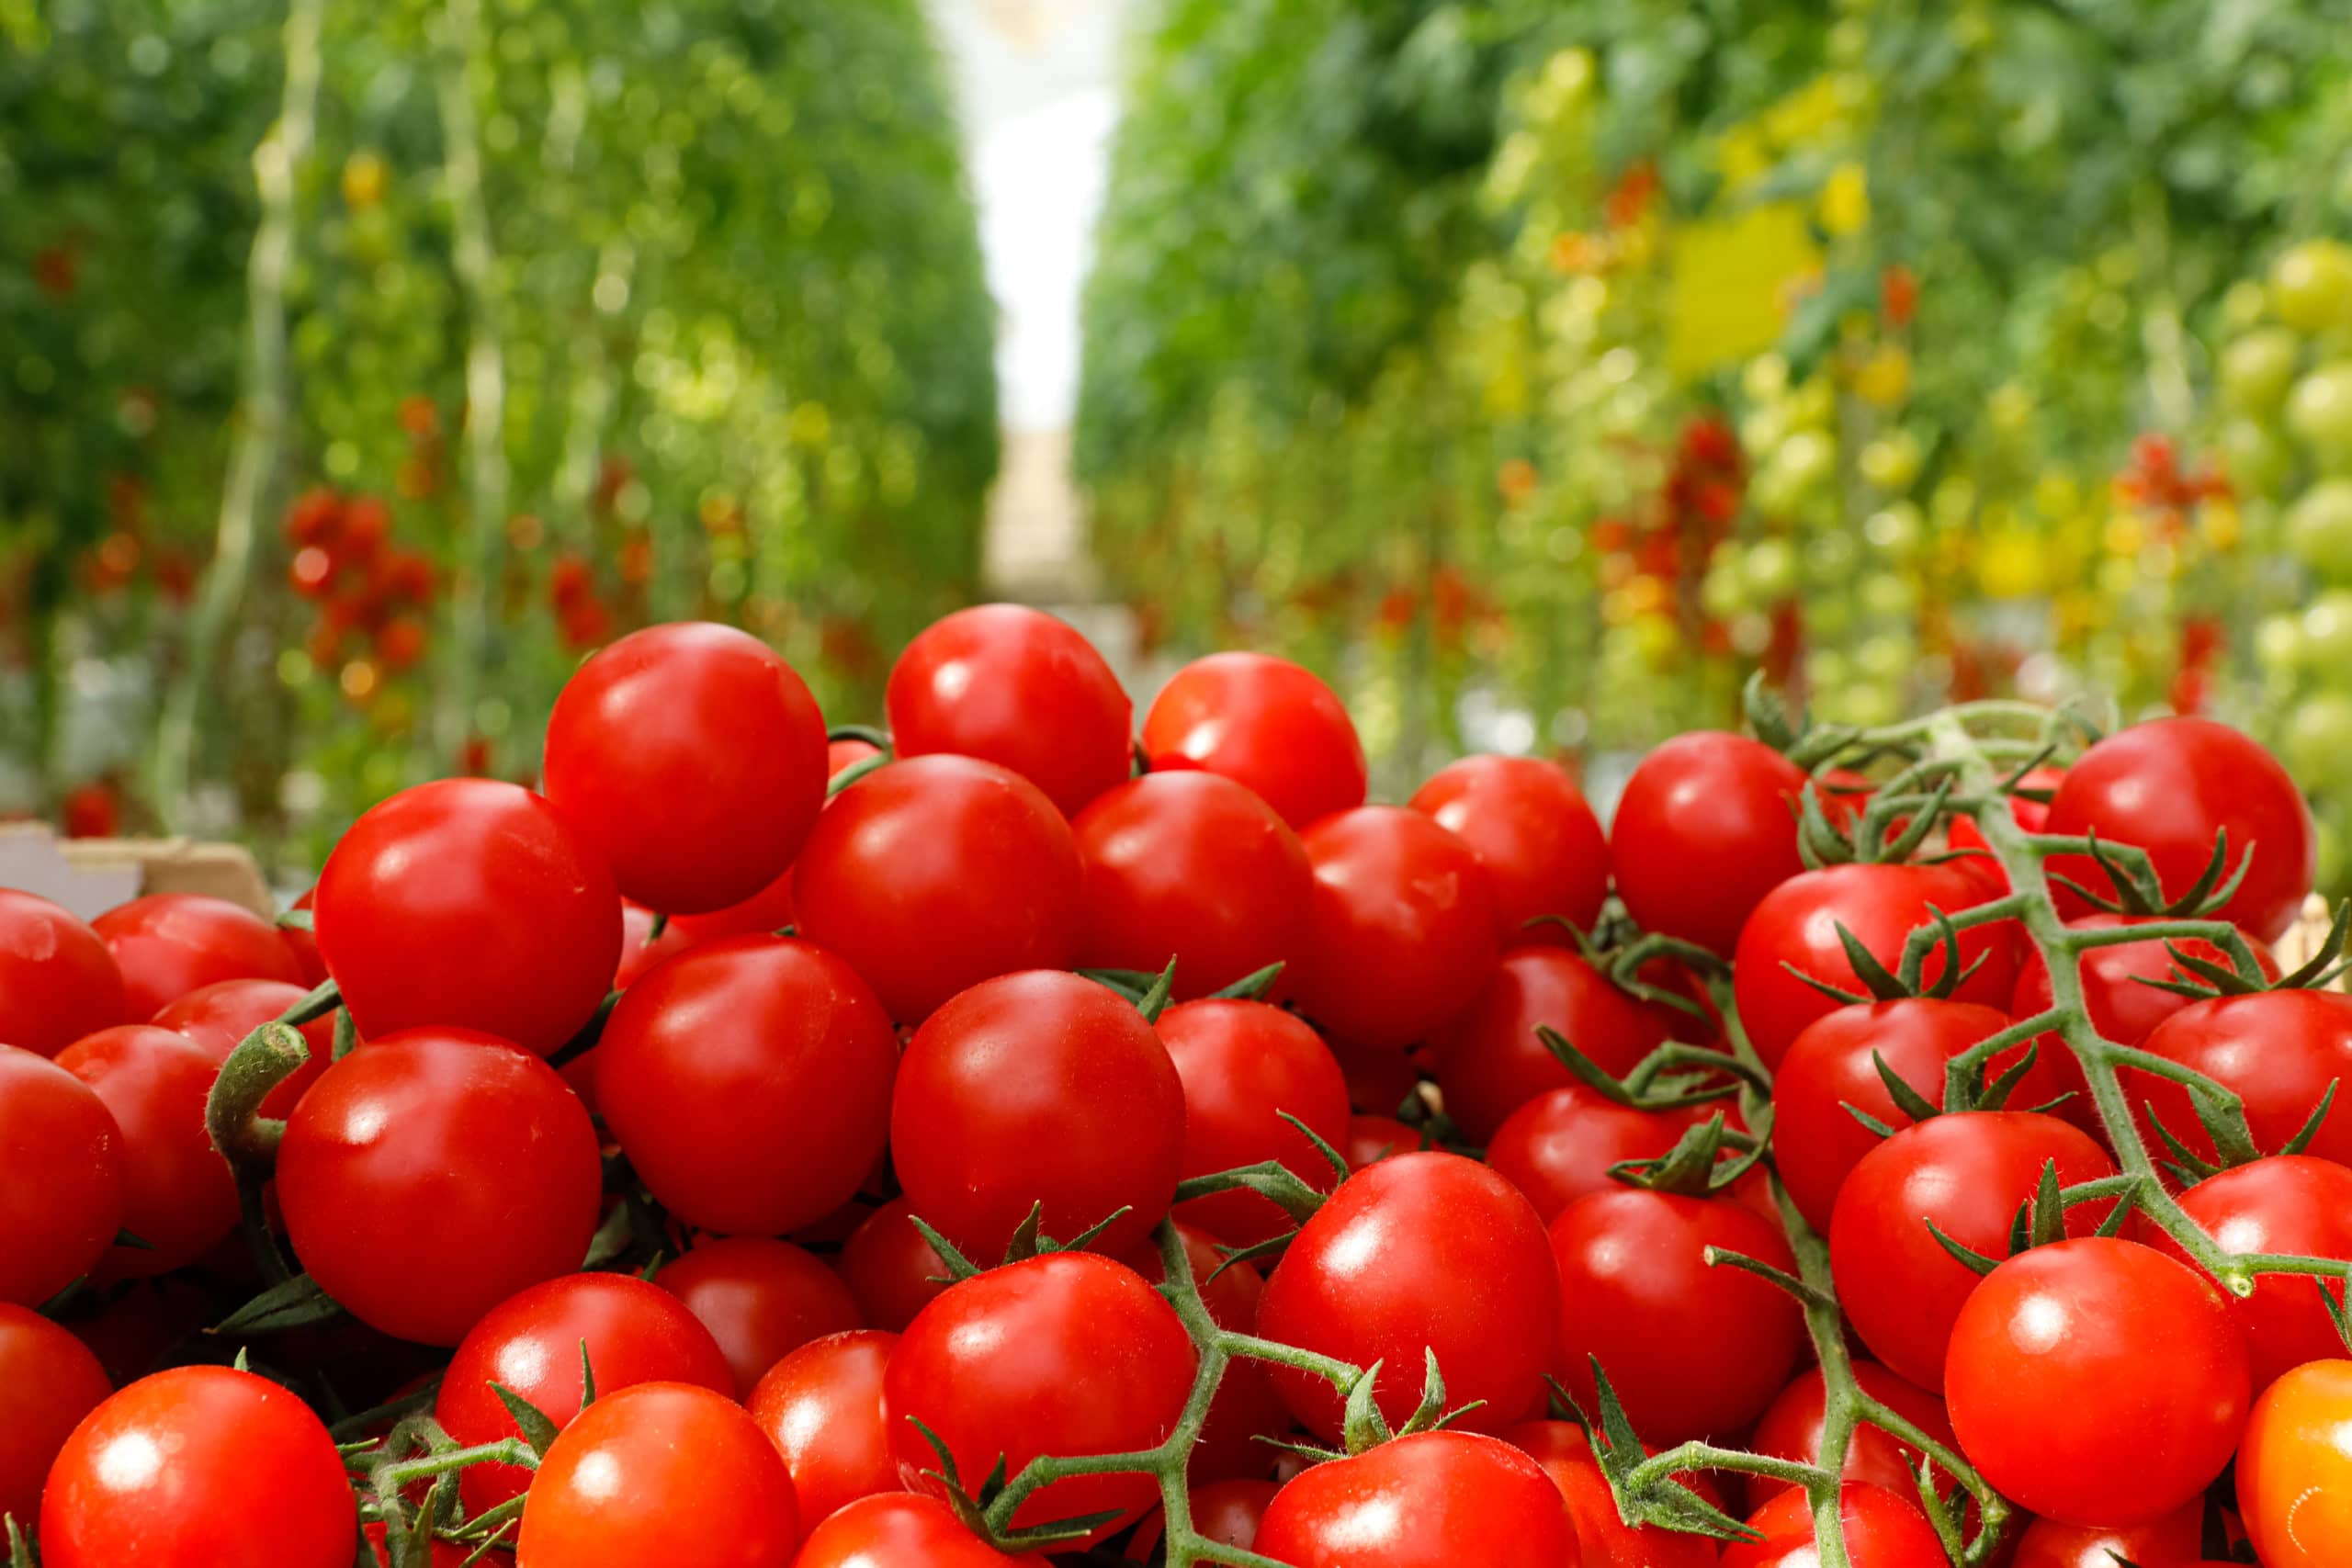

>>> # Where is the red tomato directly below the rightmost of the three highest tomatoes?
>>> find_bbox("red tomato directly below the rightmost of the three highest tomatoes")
[1070,773,1312,999]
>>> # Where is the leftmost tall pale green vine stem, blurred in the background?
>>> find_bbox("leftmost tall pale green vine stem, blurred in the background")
[155,0,327,825]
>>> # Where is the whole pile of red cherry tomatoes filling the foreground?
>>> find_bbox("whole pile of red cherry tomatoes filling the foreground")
[0,606,2352,1568]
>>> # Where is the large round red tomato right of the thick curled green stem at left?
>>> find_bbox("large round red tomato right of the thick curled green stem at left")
[277,1030,605,1345]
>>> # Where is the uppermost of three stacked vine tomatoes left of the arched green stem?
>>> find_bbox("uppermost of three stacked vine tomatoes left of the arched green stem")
[1731,865,2018,1069]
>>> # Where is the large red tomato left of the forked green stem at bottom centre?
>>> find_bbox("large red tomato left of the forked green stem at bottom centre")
[882,1253,1194,1540]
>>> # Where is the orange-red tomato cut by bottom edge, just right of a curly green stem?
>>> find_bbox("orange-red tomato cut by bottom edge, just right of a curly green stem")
[514,1382,799,1568]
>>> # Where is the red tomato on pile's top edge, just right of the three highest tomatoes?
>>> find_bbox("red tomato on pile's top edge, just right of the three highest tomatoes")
[1411,757,1609,947]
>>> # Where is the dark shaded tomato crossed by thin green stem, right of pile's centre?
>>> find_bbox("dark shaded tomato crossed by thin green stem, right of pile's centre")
[1430,947,1670,1143]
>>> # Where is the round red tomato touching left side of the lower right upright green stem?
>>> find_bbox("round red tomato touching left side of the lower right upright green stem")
[1553,1187,1804,1446]
